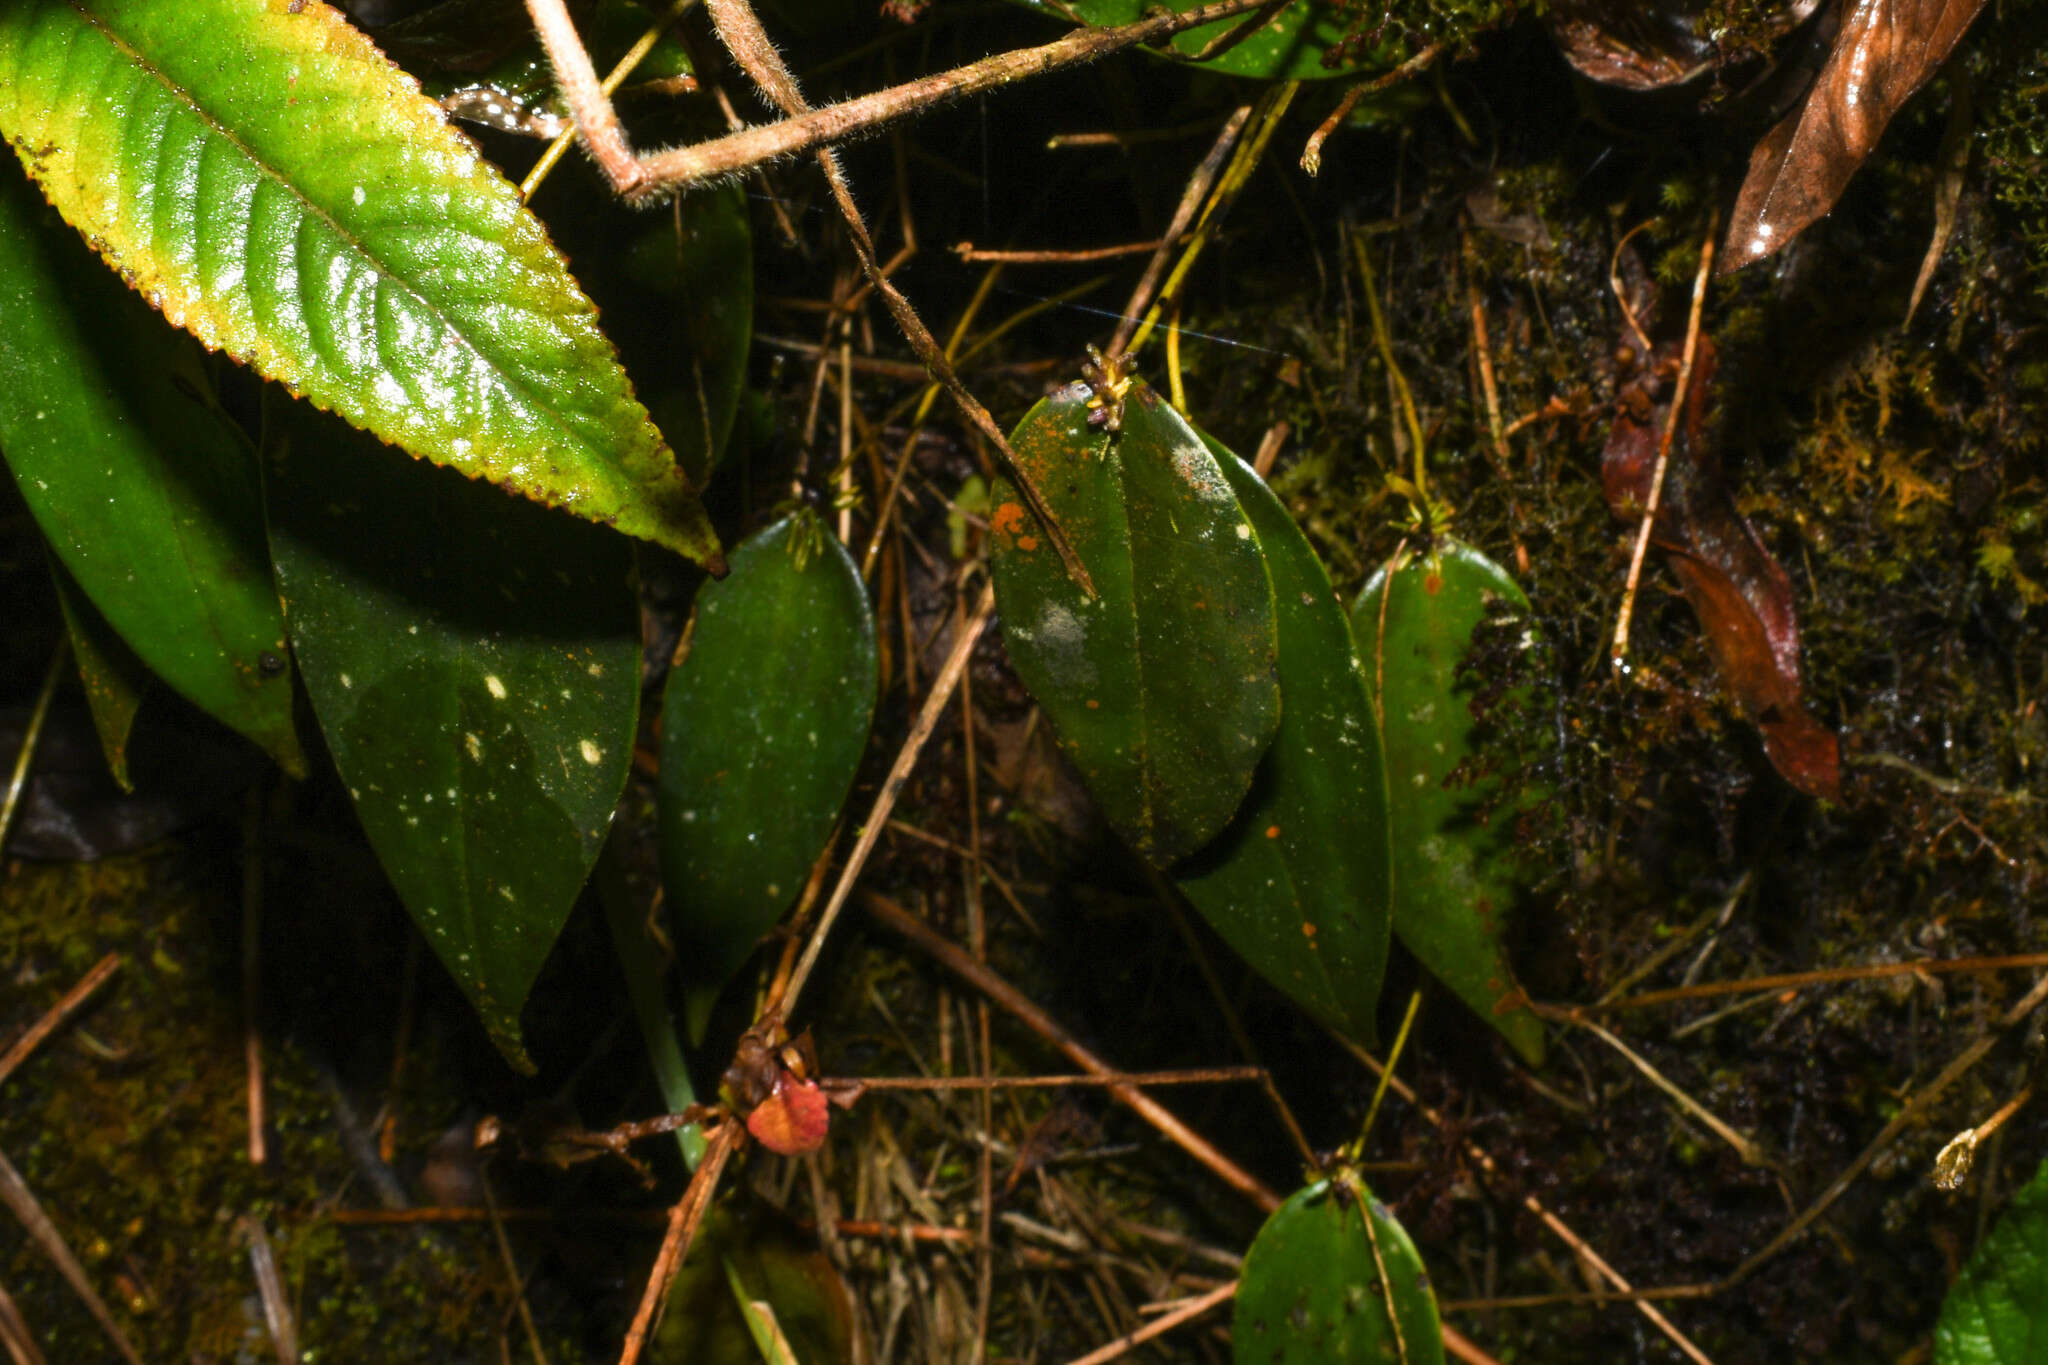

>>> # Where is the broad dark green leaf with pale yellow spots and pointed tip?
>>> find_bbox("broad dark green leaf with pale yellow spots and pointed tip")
[266,403,639,1066]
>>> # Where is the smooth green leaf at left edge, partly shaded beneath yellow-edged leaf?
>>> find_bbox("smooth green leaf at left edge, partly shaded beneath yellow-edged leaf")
[0,165,305,772]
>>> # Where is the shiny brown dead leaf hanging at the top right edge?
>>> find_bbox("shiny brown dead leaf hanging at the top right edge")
[1720,0,1985,274]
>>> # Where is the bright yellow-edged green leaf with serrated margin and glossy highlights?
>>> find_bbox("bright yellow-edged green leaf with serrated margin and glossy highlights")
[0,0,719,563]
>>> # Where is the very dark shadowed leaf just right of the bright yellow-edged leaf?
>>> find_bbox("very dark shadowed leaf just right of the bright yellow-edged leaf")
[610,184,754,483]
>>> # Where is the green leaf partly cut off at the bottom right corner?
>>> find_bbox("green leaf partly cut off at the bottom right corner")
[1933,1162,2048,1365]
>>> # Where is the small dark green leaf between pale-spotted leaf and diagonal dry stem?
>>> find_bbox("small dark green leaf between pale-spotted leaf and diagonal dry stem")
[659,512,877,1038]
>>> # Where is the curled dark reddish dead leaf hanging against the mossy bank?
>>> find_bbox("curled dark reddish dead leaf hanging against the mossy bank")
[1599,336,1841,798]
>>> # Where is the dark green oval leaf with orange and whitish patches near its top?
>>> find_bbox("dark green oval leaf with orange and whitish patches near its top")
[989,381,1280,868]
